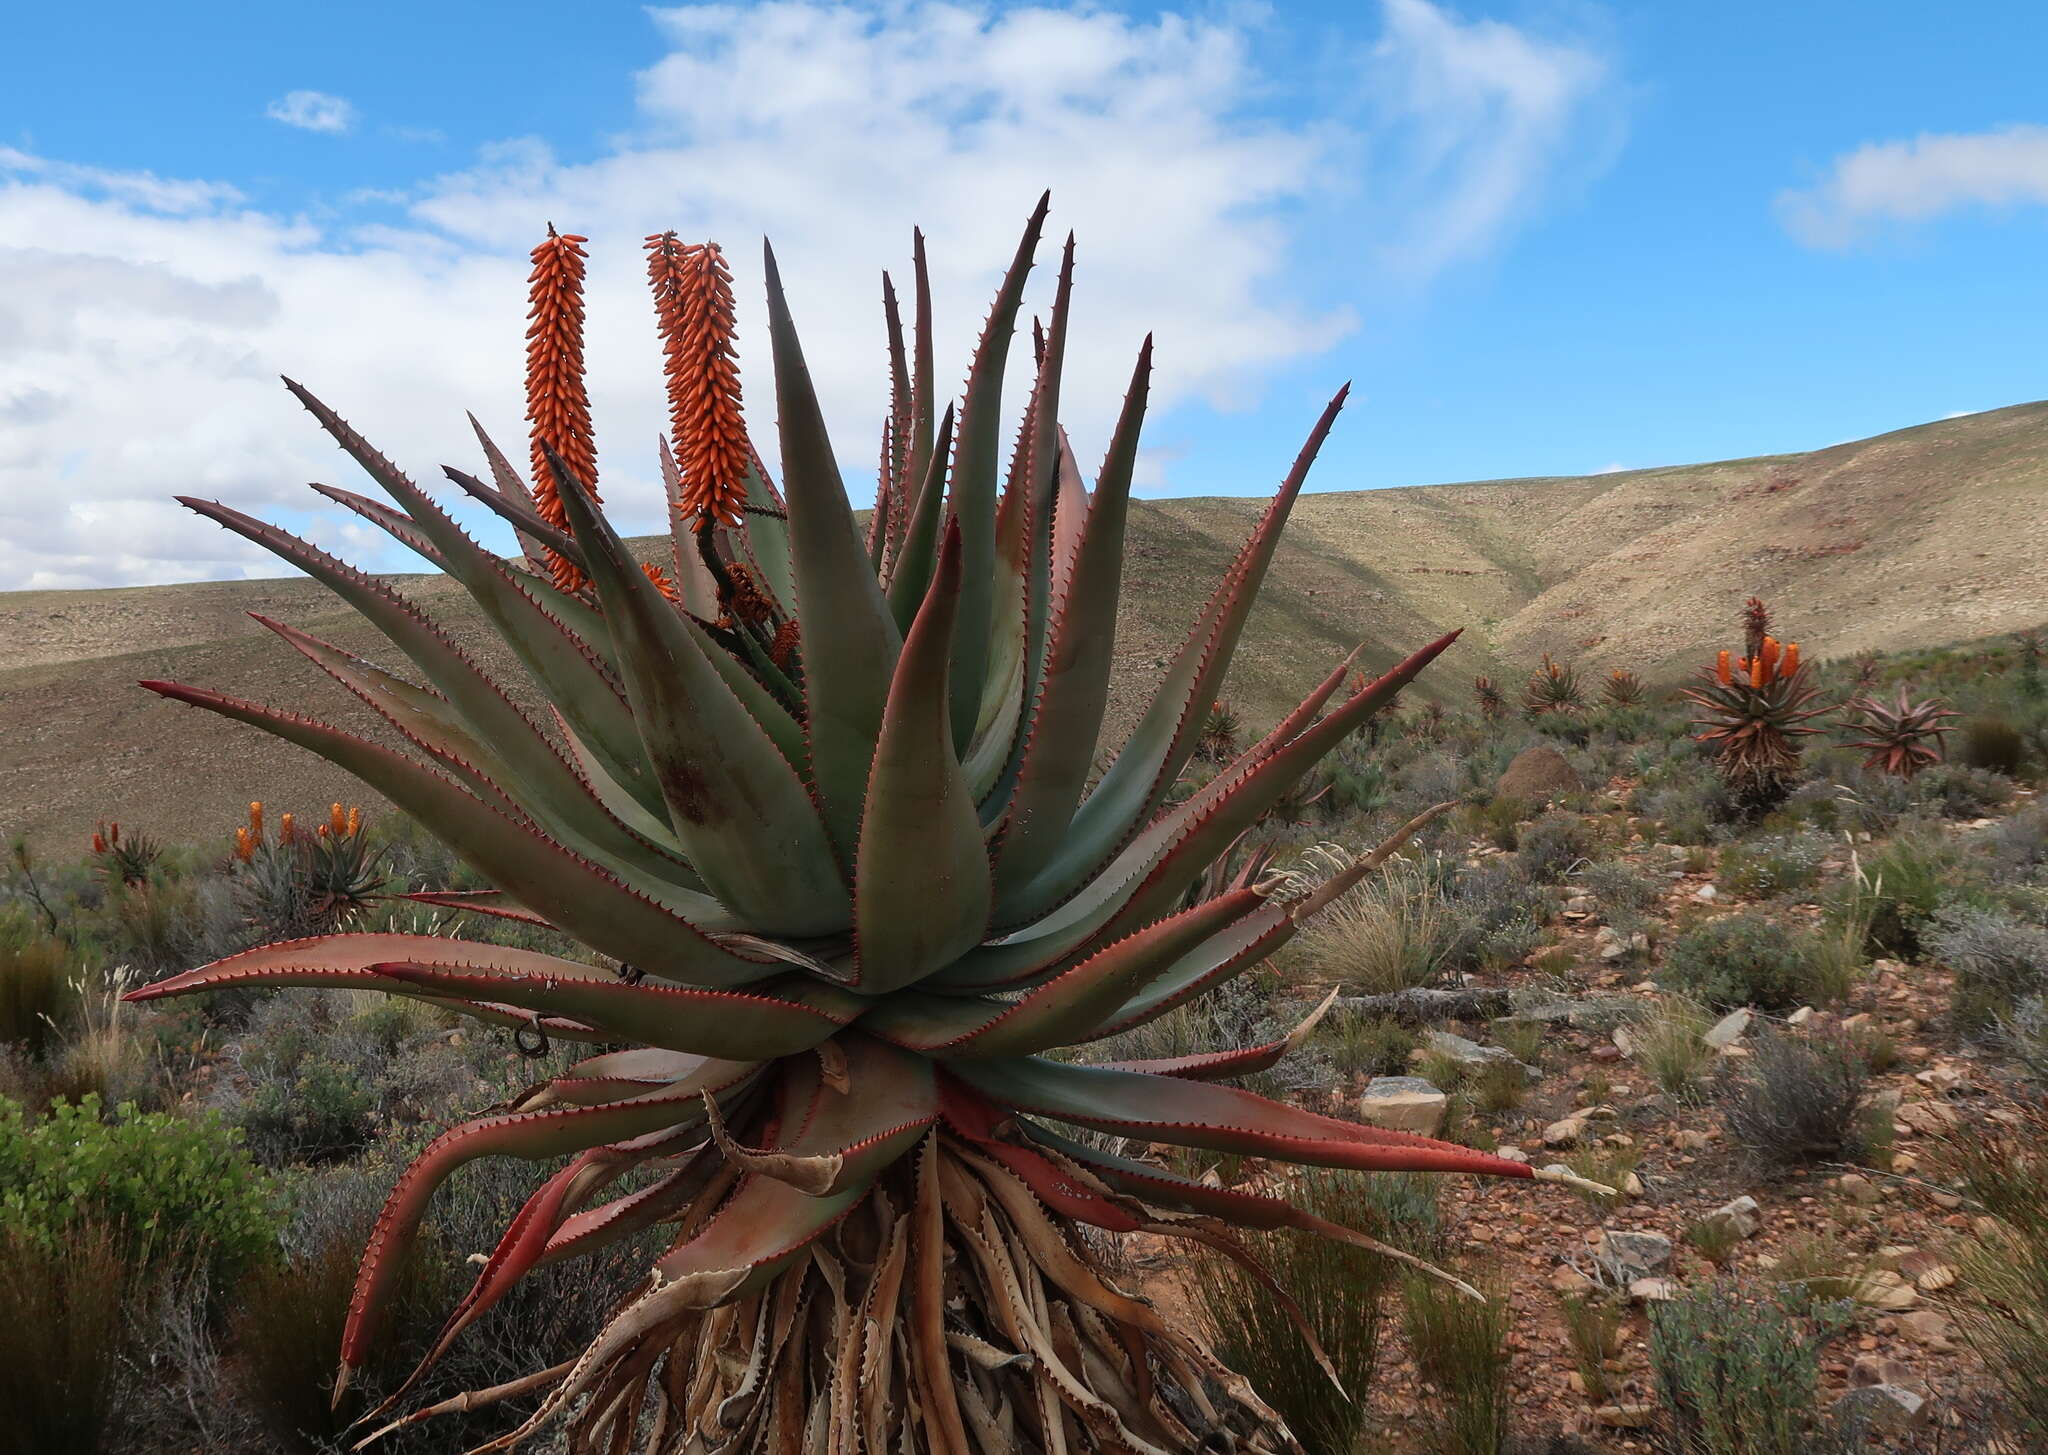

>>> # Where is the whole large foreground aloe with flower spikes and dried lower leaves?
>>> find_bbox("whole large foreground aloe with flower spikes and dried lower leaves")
[137,201,1589,1455]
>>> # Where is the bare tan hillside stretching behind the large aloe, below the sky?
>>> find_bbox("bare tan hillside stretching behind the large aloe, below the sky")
[0,402,2048,848]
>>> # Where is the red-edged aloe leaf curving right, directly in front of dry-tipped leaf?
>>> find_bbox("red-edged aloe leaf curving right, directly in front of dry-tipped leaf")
[866,889,1266,1059]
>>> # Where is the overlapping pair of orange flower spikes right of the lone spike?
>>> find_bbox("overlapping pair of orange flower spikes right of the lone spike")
[647,232,754,529]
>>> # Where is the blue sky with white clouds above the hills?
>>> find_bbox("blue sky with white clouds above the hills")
[0,0,2048,588]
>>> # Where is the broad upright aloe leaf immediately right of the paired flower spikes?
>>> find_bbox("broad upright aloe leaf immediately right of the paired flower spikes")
[766,237,903,855]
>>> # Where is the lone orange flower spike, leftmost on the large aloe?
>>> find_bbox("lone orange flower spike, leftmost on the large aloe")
[526,223,598,590]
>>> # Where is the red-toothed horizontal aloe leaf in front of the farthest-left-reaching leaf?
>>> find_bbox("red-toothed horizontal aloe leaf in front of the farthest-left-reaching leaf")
[375,961,862,1062]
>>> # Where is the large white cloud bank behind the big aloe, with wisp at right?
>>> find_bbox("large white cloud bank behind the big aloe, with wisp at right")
[0,0,1597,588]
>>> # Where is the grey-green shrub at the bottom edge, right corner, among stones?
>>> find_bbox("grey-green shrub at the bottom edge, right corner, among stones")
[1651,1283,1849,1455]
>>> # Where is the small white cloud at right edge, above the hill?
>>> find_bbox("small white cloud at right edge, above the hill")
[1778,125,2048,248]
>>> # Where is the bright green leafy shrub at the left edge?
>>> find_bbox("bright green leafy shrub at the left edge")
[0,1096,276,1277]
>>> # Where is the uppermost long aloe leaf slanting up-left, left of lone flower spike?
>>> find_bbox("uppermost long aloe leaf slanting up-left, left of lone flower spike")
[285,379,662,807]
